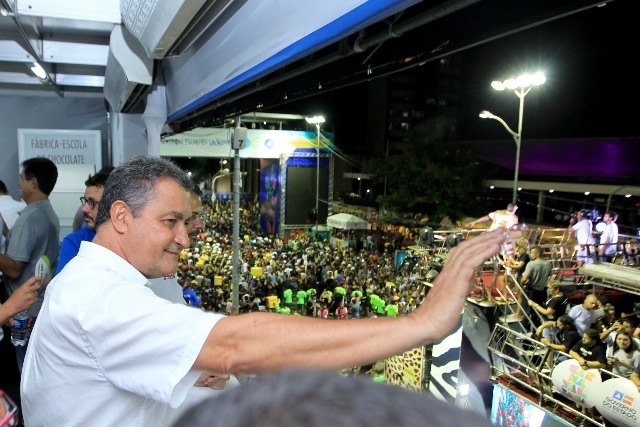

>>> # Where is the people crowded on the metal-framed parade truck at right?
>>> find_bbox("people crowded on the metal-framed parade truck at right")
[469,204,640,425]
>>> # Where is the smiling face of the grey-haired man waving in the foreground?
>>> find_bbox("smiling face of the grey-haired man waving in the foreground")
[121,179,191,278]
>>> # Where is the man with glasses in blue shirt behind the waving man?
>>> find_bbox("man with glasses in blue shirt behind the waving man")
[56,168,113,274]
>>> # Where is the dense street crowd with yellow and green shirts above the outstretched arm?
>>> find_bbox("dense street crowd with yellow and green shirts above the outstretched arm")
[178,202,426,319]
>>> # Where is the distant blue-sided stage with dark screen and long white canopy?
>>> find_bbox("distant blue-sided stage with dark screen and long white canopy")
[160,128,334,235]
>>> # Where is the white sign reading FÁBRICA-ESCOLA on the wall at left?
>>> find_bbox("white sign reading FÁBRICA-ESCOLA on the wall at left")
[18,129,102,166]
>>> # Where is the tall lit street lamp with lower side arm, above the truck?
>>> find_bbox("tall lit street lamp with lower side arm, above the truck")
[480,72,547,204]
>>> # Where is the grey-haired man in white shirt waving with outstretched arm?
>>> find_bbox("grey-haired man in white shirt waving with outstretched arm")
[20,156,504,427]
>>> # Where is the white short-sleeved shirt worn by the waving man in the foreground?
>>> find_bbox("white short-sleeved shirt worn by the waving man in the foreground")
[21,242,223,427]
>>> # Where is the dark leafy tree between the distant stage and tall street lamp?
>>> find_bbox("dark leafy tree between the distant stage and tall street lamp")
[363,142,487,222]
